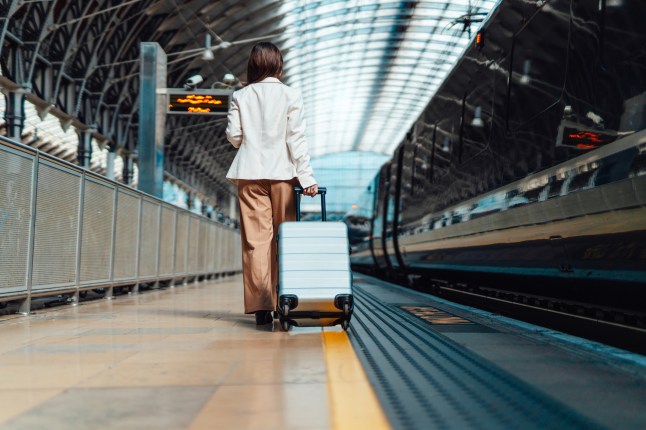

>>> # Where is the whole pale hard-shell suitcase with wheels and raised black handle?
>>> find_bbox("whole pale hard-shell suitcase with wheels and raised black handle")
[278,187,353,330]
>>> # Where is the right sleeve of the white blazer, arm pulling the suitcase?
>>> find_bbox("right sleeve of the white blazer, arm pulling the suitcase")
[287,92,316,188]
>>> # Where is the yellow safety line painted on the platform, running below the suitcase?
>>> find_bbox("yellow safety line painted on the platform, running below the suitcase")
[323,327,390,430]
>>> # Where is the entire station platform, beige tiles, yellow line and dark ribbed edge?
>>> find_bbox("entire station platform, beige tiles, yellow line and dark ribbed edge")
[0,275,646,429]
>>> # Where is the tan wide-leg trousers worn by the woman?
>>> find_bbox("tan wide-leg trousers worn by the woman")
[238,179,298,314]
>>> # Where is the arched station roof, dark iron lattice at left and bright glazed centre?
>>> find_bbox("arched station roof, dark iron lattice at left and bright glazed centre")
[0,0,497,201]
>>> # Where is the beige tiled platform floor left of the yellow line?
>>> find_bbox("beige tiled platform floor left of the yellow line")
[0,278,385,430]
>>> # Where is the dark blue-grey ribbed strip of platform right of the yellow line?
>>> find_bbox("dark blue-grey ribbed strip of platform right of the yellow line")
[348,286,598,429]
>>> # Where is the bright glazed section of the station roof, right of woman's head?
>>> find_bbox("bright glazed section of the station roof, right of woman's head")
[280,0,499,158]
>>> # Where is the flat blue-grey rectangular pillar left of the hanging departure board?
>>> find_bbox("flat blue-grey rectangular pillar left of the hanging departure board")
[137,42,166,198]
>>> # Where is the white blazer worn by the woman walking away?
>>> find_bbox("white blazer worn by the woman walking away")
[226,77,316,188]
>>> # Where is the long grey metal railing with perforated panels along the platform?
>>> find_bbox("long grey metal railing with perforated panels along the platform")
[0,137,242,313]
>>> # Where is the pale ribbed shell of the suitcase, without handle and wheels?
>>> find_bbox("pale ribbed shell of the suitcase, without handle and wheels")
[278,222,352,325]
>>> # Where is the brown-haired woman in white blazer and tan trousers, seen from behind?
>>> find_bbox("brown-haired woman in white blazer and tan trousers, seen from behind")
[226,42,318,325]
